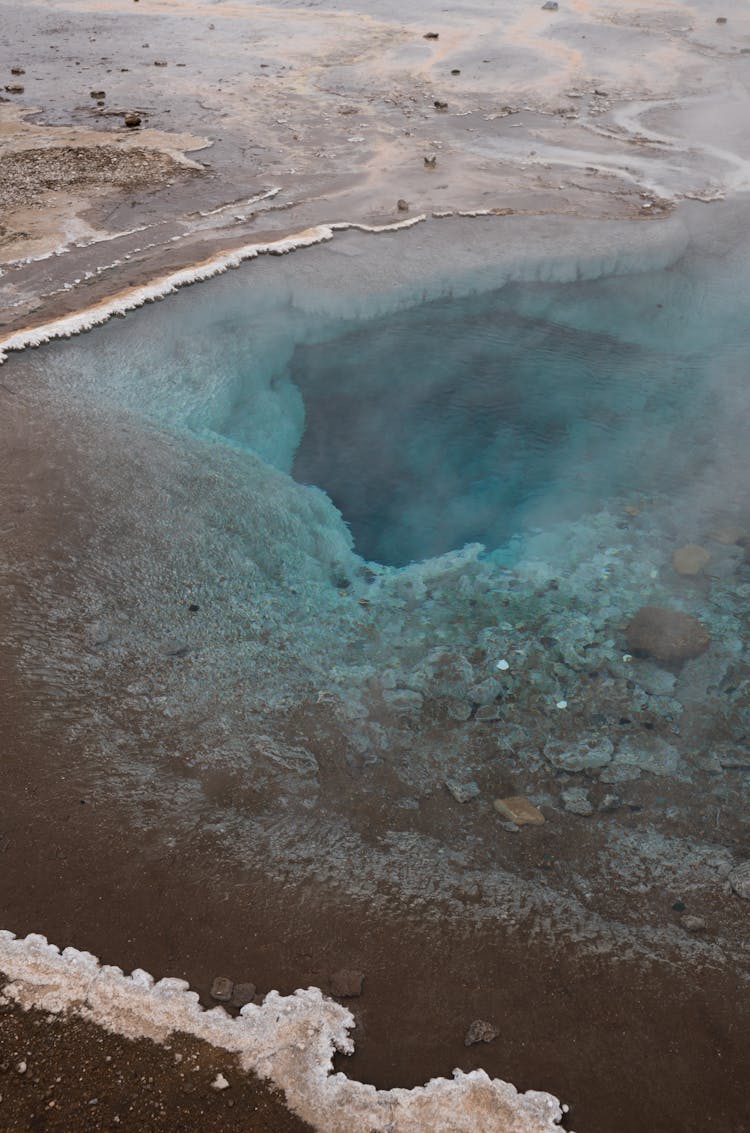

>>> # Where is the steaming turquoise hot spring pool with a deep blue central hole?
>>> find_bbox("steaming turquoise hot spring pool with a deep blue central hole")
[0,211,750,1133]
